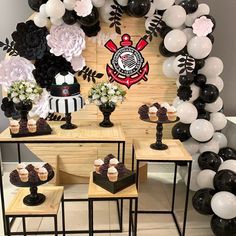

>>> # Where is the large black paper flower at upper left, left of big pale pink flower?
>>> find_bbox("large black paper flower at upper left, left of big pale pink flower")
[11,20,48,60]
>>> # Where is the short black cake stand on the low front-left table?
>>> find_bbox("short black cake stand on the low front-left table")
[11,171,54,206]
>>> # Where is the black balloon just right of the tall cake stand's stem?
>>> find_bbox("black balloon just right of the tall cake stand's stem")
[172,122,191,142]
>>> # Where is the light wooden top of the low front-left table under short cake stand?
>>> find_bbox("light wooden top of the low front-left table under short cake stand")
[6,186,64,216]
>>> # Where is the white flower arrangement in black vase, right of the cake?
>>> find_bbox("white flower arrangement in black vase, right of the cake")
[88,82,126,127]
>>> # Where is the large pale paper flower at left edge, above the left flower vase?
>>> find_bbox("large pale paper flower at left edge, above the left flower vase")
[0,56,35,88]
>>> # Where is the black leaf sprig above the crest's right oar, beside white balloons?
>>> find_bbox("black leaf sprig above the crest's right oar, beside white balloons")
[143,13,164,42]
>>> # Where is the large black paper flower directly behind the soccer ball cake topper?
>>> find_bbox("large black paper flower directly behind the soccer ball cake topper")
[33,52,75,90]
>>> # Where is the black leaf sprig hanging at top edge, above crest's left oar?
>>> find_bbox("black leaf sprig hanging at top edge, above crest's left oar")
[109,0,124,34]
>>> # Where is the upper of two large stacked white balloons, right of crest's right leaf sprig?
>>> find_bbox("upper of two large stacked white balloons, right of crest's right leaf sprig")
[162,5,186,29]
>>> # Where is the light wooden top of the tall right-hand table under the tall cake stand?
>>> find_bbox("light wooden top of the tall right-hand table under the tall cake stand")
[133,139,192,161]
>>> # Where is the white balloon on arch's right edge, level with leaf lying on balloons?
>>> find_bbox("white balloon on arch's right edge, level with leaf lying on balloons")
[199,57,224,77]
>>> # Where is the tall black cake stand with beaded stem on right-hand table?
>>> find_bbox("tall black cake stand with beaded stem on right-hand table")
[141,117,179,150]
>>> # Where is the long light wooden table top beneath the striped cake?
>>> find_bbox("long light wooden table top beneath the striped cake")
[0,122,125,143]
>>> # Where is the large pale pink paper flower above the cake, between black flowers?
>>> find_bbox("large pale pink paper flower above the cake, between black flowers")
[47,24,85,61]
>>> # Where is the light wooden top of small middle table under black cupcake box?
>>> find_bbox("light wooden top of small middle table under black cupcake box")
[88,174,138,198]
